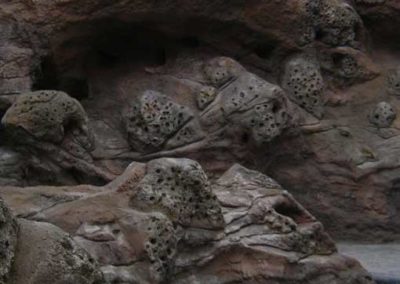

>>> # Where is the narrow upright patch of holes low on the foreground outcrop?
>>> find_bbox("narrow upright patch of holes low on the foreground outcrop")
[145,216,178,280]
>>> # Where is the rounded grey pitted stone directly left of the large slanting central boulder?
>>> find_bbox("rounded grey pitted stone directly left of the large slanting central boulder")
[125,91,192,151]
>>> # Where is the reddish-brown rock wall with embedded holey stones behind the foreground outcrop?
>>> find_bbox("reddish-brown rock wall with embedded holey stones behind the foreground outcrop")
[0,0,400,262]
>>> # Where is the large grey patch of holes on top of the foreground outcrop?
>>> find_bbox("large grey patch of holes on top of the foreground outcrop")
[137,159,223,227]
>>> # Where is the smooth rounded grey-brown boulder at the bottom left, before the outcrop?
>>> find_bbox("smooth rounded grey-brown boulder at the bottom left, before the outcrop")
[9,219,104,284]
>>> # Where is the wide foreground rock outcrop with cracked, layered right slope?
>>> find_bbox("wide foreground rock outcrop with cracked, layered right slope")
[0,158,373,283]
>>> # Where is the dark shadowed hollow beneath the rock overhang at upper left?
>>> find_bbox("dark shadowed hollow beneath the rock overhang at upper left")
[33,20,194,100]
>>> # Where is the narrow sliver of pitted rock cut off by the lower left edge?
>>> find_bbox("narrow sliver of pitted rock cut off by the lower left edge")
[0,198,18,284]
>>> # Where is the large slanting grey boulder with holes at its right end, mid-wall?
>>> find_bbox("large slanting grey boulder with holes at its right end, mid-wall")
[201,57,290,145]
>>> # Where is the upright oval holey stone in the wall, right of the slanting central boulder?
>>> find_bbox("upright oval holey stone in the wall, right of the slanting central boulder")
[282,57,324,117]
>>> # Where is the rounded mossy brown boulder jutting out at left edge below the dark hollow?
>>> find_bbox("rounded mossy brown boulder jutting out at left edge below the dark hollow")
[2,90,94,150]
